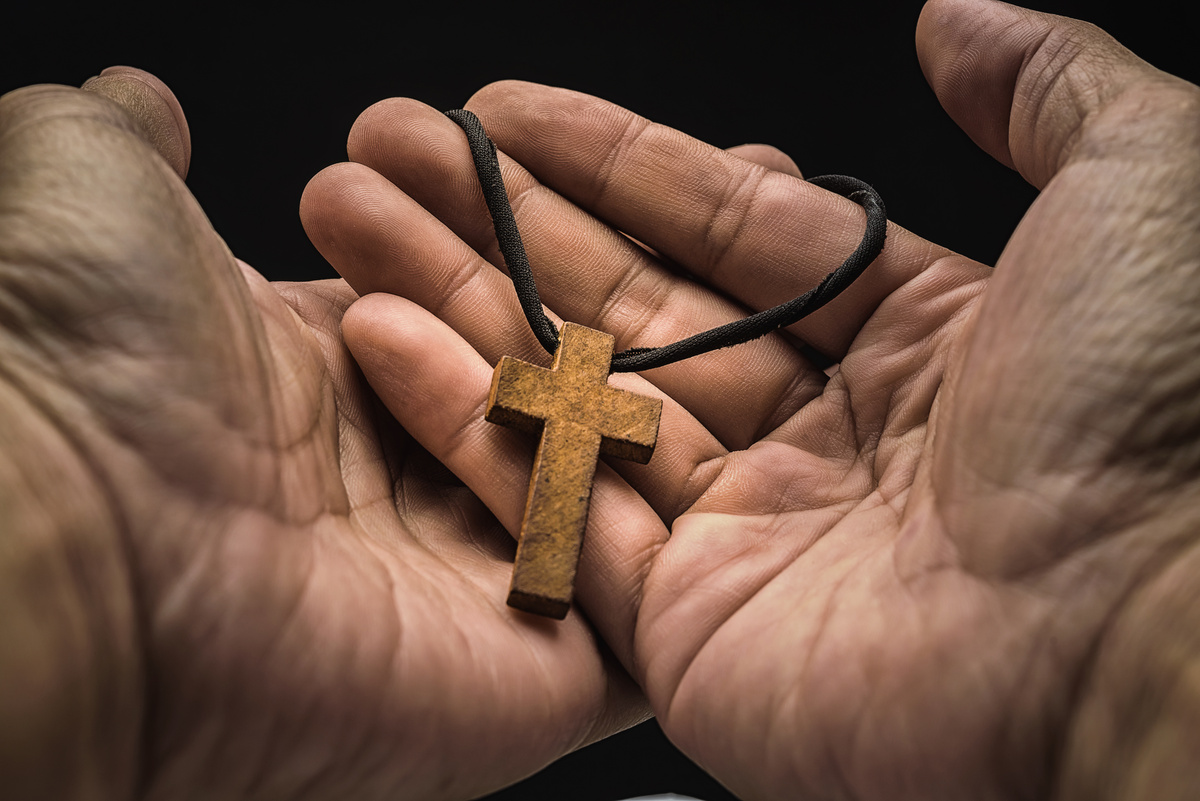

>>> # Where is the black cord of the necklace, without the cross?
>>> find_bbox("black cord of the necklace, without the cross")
[445,109,888,373]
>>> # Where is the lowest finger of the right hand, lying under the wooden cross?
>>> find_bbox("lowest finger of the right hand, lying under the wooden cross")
[342,294,667,675]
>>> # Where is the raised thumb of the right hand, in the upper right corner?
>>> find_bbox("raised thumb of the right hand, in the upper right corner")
[917,0,1183,188]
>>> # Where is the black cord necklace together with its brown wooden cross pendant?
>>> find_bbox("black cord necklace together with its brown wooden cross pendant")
[446,109,887,620]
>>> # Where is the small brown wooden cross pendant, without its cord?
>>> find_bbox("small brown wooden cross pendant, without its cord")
[484,323,662,620]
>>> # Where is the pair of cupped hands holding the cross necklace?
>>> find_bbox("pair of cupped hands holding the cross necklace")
[0,0,1200,799]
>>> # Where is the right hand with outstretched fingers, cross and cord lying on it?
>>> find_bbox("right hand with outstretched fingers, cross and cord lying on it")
[301,0,1200,801]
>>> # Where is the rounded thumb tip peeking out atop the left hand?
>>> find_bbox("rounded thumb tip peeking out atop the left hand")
[83,67,192,177]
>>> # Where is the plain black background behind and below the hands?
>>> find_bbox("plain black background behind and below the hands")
[0,0,1200,801]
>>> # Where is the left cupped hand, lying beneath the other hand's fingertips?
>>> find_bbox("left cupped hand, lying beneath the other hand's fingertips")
[0,68,644,800]
